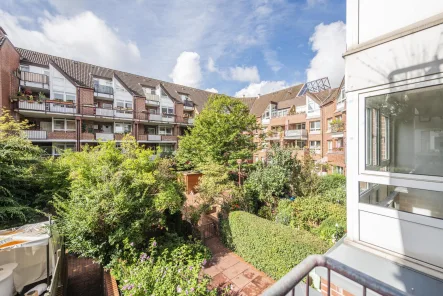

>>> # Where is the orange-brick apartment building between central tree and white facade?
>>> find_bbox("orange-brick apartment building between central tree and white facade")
[246,78,346,174]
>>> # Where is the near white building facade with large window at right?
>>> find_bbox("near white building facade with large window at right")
[344,0,443,282]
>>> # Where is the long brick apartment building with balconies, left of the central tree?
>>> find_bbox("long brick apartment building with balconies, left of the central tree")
[0,29,212,155]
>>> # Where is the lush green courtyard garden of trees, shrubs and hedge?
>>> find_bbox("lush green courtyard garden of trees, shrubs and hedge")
[0,95,346,295]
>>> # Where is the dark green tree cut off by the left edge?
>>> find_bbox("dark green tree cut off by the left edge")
[0,109,46,227]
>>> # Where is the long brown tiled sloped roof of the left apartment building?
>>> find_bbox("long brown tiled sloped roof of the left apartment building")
[17,48,213,111]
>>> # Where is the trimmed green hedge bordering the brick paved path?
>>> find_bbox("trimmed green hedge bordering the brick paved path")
[220,211,328,280]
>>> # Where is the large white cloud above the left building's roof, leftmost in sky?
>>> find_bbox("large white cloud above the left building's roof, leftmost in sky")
[0,10,140,72]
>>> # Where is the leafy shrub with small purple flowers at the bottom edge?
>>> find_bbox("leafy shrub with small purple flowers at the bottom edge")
[112,236,217,296]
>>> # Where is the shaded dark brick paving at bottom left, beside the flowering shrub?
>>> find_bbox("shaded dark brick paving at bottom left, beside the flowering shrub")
[66,254,103,296]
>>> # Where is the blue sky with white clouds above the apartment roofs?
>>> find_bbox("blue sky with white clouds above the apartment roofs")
[0,0,346,97]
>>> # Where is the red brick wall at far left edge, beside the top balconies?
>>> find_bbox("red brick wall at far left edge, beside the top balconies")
[0,40,20,109]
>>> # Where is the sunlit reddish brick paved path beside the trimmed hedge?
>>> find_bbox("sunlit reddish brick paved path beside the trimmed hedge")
[203,237,274,296]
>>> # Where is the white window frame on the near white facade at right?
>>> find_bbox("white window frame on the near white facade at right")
[358,79,443,237]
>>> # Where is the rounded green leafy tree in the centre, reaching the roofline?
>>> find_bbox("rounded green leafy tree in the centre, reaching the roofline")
[176,95,257,169]
